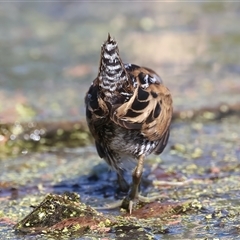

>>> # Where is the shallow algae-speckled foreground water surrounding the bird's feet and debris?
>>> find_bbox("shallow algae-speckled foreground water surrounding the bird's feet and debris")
[0,117,240,239]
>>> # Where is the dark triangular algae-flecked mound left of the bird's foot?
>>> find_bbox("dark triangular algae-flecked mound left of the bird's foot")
[14,193,111,235]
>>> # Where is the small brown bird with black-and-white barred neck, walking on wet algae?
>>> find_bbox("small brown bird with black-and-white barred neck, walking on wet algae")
[85,34,173,213]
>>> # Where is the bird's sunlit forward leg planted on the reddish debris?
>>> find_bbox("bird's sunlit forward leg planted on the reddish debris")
[122,155,144,213]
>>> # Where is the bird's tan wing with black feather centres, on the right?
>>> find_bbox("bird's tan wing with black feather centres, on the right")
[110,66,172,142]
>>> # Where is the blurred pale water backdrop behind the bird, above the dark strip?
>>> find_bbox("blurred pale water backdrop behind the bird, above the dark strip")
[0,1,240,123]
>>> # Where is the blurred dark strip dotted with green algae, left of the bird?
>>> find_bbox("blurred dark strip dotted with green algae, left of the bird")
[0,121,92,159]
